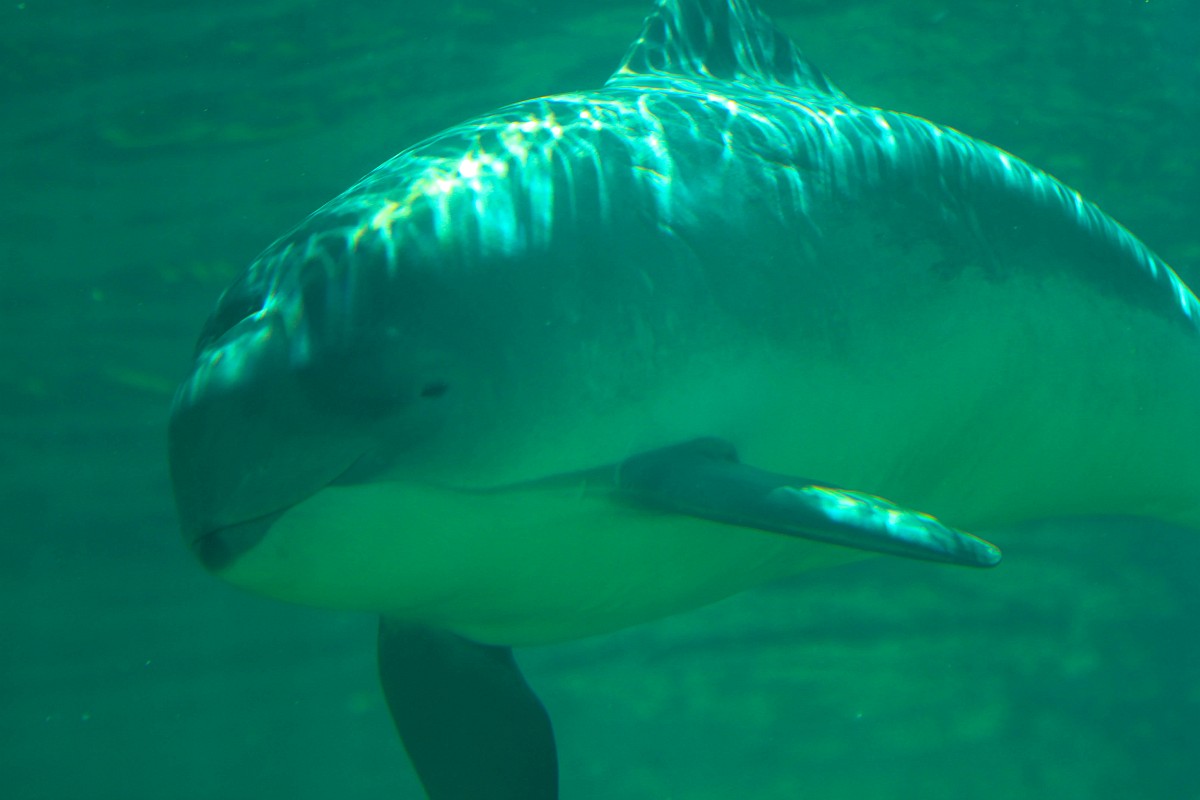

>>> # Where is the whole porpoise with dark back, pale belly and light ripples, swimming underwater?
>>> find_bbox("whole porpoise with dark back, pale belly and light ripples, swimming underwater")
[169,0,1200,800]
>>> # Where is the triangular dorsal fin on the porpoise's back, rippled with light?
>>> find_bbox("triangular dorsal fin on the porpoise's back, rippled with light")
[608,0,842,97]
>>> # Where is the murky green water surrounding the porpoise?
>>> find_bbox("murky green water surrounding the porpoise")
[0,0,1200,800]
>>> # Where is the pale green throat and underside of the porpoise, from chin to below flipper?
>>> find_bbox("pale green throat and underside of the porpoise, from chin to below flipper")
[222,483,865,644]
